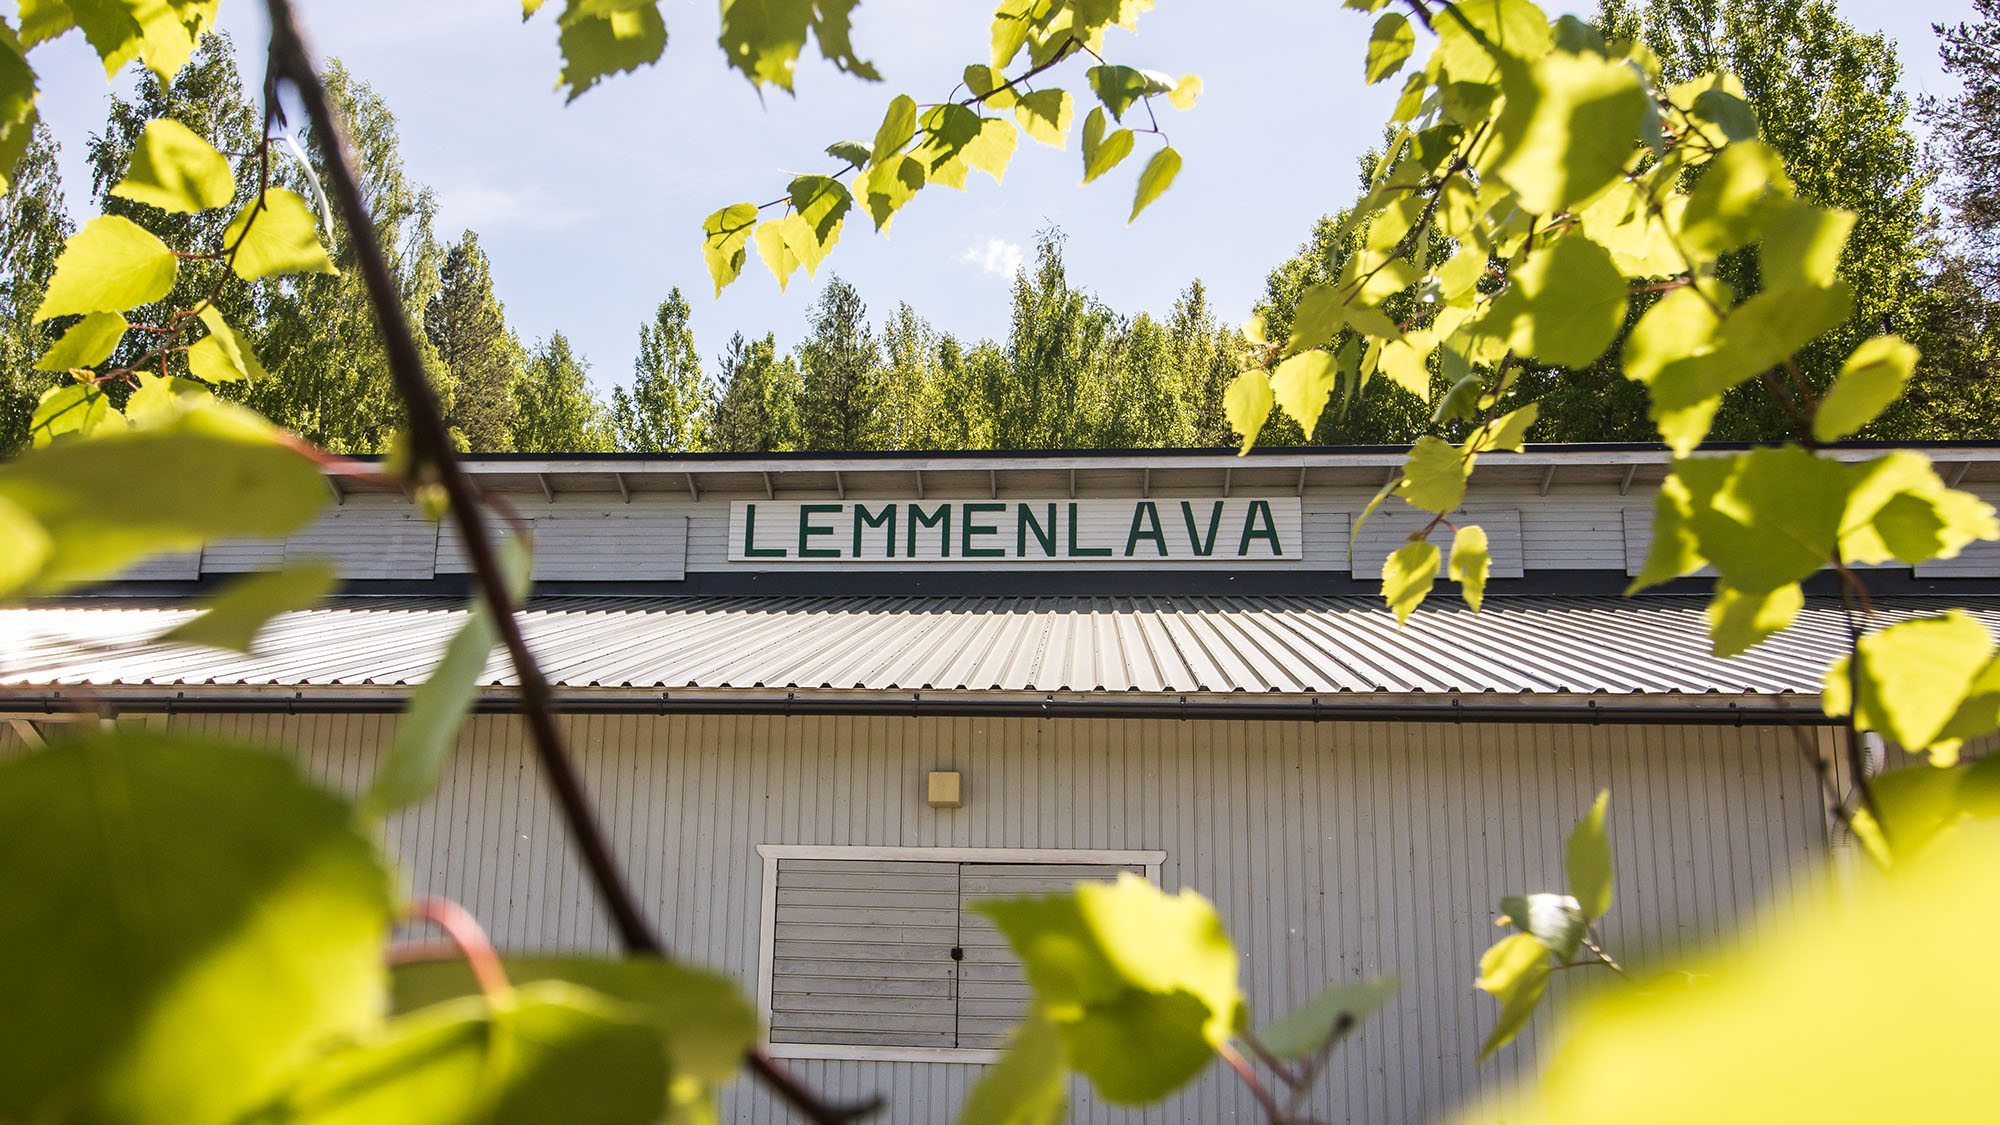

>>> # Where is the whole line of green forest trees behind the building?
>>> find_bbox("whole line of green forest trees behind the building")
[0,0,2000,452]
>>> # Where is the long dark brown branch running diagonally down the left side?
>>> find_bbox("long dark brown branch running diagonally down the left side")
[266,0,880,1125]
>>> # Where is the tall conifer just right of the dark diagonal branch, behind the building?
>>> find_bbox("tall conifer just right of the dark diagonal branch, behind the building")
[424,230,522,452]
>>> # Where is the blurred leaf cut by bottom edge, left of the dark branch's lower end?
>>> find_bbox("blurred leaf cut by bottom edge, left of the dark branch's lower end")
[268,981,668,1125]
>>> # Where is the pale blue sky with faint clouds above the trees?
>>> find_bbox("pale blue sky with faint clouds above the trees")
[0,0,1972,386]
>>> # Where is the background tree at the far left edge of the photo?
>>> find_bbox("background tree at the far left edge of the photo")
[0,124,72,454]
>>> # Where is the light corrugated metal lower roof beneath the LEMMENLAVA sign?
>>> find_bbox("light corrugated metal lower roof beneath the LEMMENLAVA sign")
[0,597,2000,695]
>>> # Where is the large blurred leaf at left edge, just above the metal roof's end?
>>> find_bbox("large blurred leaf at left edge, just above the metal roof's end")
[0,406,326,593]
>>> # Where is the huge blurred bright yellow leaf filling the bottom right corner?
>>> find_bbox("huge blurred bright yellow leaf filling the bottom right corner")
[1460,821,2000,1125]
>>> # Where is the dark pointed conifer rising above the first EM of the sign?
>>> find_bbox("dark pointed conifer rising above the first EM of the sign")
[798,276,882,452]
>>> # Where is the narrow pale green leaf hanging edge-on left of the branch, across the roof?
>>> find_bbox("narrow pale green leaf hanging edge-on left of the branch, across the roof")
[362,536,530,817]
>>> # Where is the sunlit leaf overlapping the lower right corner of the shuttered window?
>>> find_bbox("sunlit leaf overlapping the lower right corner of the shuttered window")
[980,873,1244,1103]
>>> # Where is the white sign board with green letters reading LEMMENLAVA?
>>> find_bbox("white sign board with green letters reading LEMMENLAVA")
[730,496,1304,567]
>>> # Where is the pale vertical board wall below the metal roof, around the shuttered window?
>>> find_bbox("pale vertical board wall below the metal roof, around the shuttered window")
[174,715,1826,1123]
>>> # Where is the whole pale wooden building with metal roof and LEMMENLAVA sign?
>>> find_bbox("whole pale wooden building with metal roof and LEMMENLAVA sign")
[0,446,2000,1121]
